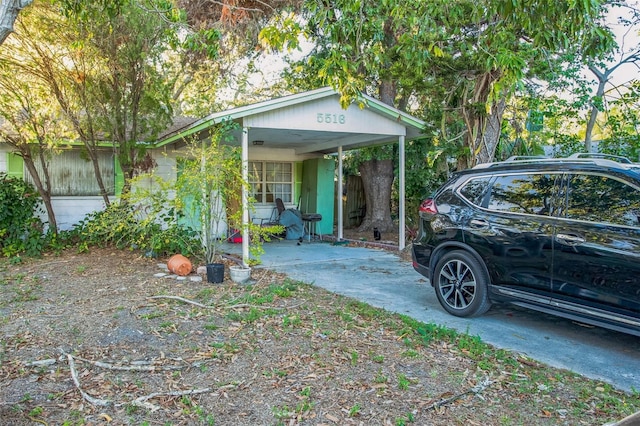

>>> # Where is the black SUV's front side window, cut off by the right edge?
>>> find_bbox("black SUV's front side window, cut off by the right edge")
[566,175,640,227]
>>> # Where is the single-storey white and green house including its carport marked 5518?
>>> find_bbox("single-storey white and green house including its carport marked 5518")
[0,88,424,258]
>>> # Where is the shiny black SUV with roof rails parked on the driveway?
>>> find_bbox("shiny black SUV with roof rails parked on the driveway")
[412,155,640,336]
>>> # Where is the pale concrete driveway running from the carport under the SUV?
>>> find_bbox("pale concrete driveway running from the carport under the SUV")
[223,240,640,392]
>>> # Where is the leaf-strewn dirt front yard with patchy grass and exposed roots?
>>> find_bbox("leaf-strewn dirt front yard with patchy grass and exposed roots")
[0,238,640,426]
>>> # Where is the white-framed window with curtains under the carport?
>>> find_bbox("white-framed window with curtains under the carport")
[249,161,293,204]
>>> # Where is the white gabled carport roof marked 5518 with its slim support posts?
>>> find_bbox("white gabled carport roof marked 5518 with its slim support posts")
[156,87,424,264]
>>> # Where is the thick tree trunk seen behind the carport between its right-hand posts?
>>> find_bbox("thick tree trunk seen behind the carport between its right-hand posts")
[358,159,395,232]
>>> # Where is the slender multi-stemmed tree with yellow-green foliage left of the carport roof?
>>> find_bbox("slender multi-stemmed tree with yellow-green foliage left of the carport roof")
[59,0,177,192]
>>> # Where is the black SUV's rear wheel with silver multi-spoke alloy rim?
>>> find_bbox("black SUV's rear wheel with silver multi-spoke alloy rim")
[433,250,491,317]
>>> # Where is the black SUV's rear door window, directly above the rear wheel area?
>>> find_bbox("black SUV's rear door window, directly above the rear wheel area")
[488,173,557,216]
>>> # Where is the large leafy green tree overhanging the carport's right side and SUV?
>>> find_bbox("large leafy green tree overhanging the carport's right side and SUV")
[261,0,612,230]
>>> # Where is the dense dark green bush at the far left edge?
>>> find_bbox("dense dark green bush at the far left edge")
[0,173,46,257]
